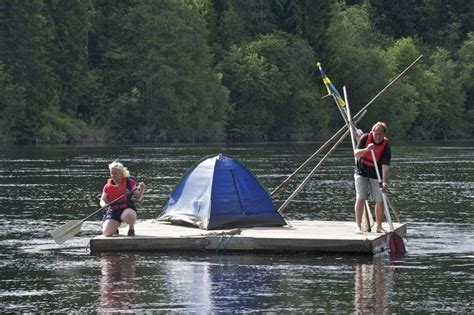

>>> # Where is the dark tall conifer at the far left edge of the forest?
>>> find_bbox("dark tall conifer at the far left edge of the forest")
[0,0,58,143]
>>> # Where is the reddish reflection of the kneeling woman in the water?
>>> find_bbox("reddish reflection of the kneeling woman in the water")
[99,255,137,312]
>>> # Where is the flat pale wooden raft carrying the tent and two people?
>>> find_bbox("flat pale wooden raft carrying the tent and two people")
[90,220,406,255]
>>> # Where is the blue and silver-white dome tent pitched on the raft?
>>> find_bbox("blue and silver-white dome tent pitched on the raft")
[158,154,286,230]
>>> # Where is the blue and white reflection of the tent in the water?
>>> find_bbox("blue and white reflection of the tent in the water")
[163,254,293,314]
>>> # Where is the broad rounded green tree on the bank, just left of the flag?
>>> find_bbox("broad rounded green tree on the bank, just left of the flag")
[218,34,326,141]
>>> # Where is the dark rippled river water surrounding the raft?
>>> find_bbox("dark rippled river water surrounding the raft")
[0,142,474,314]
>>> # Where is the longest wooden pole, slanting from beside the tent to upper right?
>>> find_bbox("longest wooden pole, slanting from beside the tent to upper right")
[270,55,423,197]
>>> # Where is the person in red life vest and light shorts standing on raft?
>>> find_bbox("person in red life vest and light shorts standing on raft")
[354,121,392,234]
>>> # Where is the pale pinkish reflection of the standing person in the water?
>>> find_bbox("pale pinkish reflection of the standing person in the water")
[354,255,390,314]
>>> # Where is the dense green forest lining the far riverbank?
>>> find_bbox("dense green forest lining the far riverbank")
[0,0,474,144]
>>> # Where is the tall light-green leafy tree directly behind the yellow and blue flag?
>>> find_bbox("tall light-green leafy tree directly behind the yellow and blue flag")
[321,6,389,127]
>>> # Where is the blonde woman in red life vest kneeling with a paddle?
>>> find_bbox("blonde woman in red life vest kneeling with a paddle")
[100,161,145,236]
